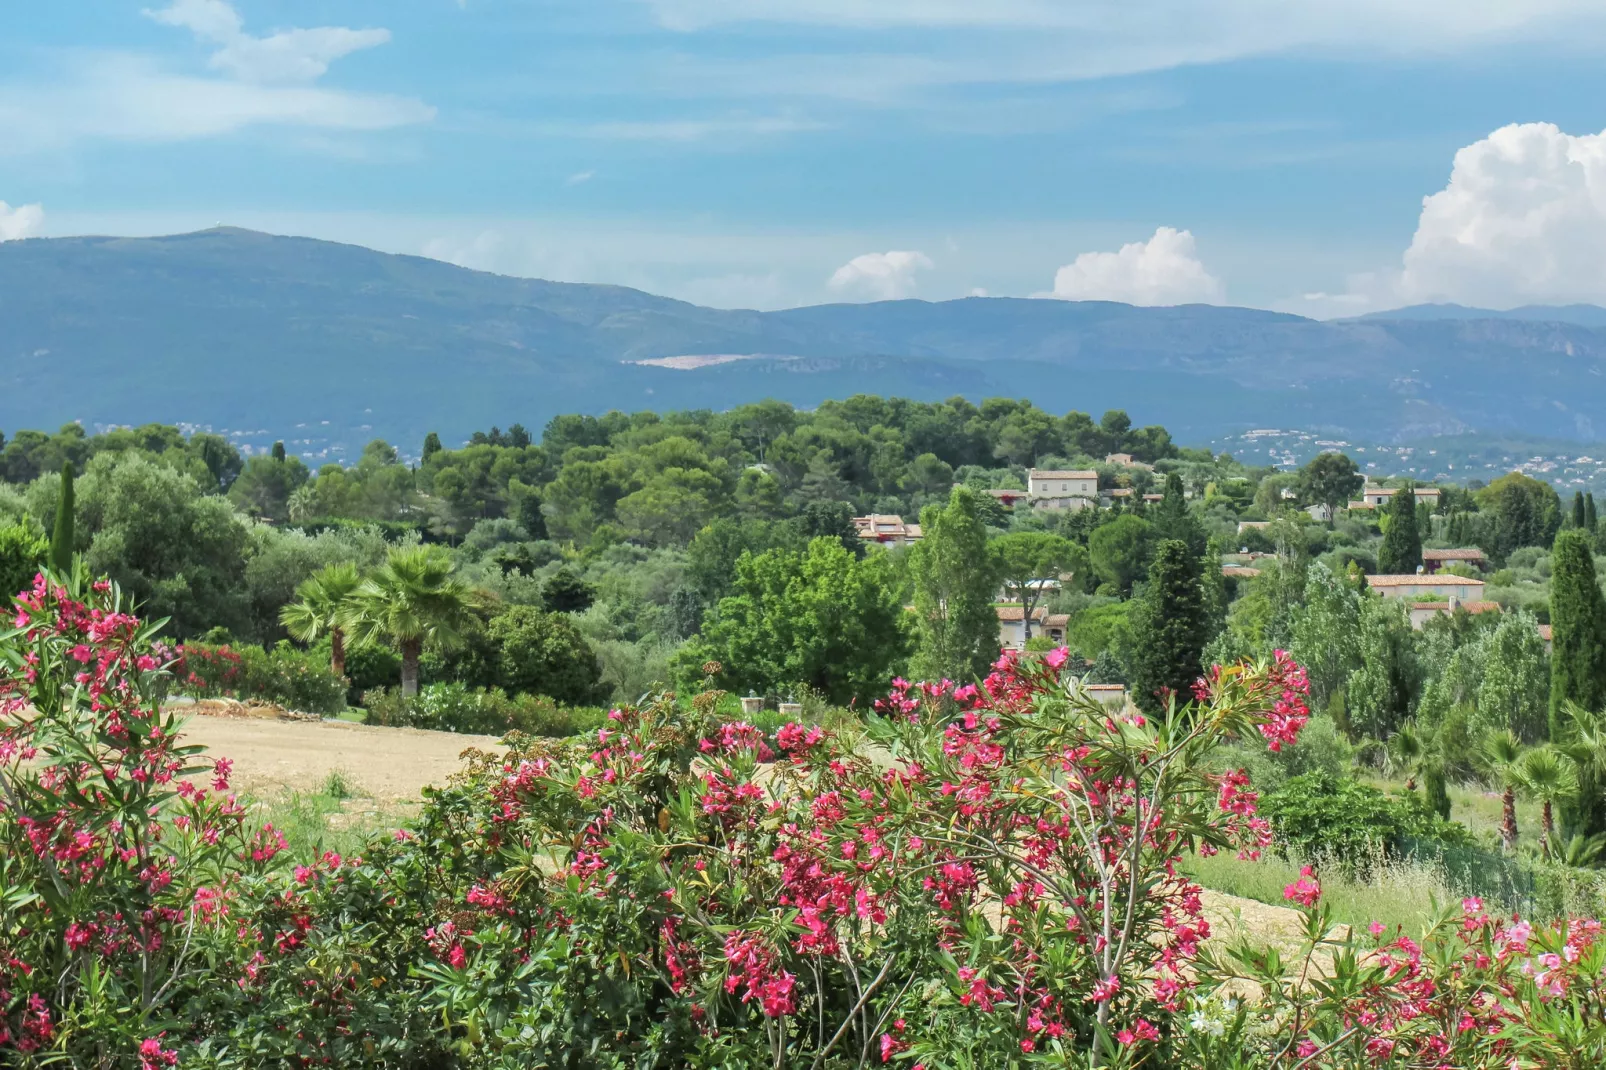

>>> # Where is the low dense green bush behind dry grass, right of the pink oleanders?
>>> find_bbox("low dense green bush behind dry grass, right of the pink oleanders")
[1261,770,1471,872]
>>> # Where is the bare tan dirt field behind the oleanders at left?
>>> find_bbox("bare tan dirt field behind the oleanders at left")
[175,715,496,802]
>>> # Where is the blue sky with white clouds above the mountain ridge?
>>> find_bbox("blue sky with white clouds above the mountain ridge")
[0,0,1606,317]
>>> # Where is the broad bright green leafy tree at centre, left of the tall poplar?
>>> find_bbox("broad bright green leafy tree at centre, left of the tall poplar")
[690,538,909,705]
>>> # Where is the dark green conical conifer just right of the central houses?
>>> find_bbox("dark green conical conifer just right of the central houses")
[1129,538,1206,713]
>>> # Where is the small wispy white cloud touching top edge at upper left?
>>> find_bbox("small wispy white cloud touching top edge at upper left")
[146,0,390,82]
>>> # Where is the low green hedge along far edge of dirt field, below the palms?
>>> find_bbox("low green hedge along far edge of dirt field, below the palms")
[363,683,607,737]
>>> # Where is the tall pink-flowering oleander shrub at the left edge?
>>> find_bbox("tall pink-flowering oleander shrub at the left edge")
[0,577,283,1067]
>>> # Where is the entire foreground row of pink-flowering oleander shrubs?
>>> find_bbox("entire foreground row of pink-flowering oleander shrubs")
[0,580,1606,1070]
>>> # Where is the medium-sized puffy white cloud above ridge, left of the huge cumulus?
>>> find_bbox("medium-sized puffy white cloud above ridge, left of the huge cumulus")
[1046,227,1225,305]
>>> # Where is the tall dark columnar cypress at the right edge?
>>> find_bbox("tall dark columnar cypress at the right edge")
[1550,532,1606,742]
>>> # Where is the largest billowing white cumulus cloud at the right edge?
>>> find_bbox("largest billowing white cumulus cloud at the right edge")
[1399,122,1606,305]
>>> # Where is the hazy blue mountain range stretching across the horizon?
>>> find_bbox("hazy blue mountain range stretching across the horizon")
[0,228,1606,456]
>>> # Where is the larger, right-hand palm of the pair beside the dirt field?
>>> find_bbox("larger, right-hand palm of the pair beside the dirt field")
[340,546,471,697]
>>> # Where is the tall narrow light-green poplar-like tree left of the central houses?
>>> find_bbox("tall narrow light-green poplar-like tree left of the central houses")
[909,487,999,683]
